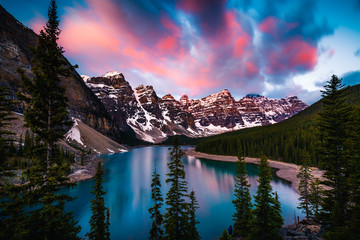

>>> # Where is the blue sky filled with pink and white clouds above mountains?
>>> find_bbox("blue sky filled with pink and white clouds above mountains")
[0,0,360,104]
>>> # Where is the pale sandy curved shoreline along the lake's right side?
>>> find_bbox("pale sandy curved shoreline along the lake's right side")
[185,148,323,194]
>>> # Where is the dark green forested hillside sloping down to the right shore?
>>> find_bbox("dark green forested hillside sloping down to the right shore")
[194,85,360,165]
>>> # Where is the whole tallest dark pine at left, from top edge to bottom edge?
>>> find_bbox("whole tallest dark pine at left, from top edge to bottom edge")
[18,0,80,239]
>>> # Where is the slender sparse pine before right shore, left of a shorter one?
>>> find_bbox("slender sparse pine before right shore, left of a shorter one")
[297,150,313,220]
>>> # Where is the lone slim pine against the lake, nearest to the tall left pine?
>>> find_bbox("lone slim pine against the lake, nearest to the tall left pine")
[87,161,110,240]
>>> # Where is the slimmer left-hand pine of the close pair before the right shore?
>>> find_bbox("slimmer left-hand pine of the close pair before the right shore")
[233,154,252,237]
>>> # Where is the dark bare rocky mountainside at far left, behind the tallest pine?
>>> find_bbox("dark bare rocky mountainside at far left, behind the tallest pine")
[0,5,141,144]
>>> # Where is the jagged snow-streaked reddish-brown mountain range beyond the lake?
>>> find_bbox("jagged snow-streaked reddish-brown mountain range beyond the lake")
[82,71,308,142]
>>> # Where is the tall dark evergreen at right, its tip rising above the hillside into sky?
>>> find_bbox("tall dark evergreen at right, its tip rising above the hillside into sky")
[318,75,351,239]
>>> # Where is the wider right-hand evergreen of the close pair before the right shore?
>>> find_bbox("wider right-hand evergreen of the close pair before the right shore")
[249,156,283,240]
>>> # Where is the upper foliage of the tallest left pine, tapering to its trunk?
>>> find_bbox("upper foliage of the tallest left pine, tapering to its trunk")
[18,0,72,165]
